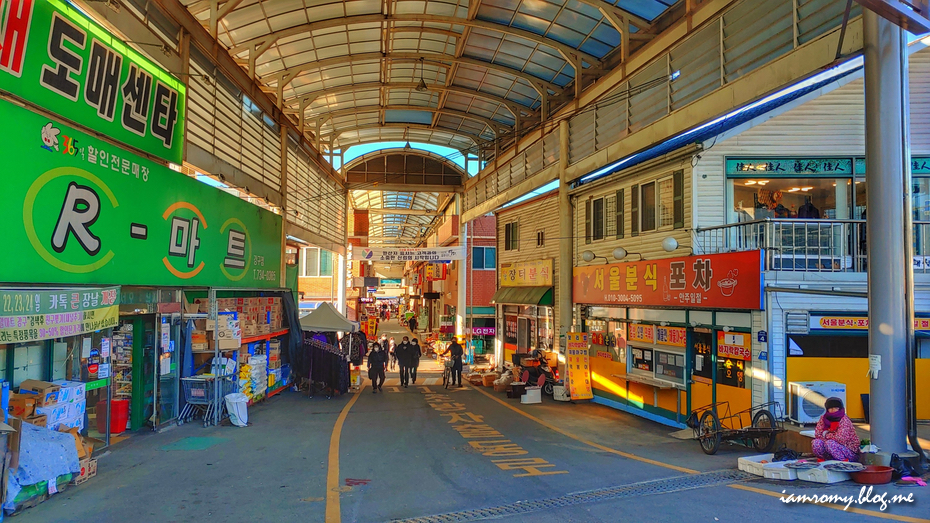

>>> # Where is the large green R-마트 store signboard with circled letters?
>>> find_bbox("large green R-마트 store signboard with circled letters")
[0,101,282,288]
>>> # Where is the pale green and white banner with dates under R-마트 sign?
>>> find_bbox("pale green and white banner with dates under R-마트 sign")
[0,287,120,343]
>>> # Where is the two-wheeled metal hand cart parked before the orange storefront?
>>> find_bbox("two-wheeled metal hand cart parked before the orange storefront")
[686,401,785,454]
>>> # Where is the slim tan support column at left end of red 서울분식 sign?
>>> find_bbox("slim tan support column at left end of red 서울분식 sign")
[556,119,574,354]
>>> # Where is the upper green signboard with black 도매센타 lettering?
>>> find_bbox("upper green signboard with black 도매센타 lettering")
[0,0,186,163]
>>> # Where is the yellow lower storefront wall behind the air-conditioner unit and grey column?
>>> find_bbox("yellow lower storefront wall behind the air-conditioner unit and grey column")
[784,357,930,420]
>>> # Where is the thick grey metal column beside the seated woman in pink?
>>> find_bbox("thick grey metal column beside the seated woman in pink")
[864,9,914,454]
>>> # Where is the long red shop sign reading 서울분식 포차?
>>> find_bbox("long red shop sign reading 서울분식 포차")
[572,251,762,310]
